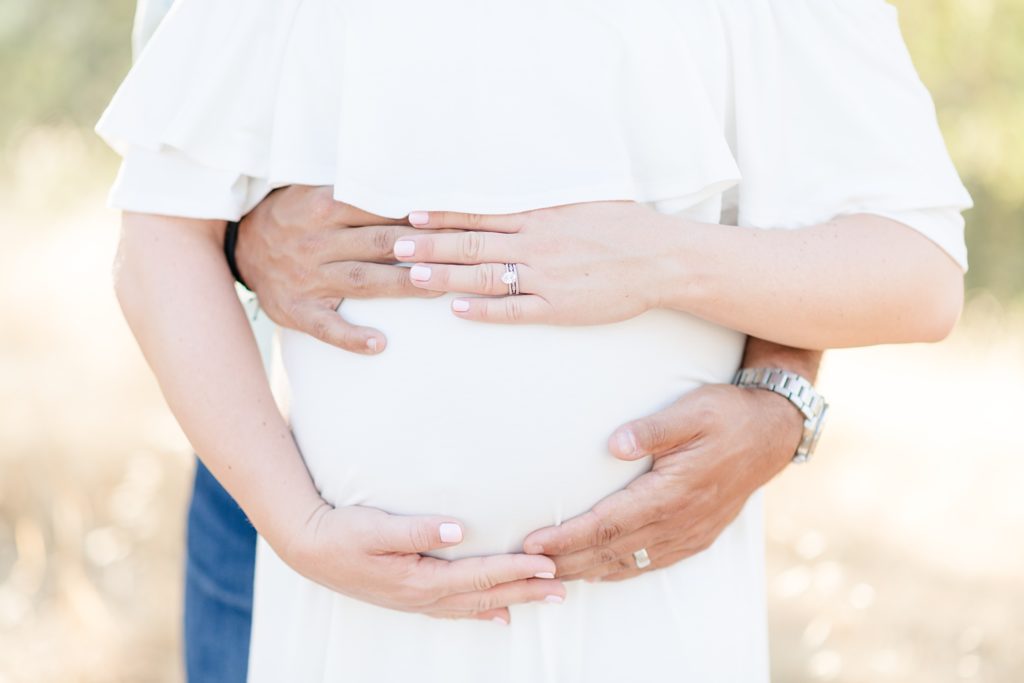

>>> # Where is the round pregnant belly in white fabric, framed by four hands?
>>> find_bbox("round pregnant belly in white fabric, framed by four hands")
[282,296,744,558]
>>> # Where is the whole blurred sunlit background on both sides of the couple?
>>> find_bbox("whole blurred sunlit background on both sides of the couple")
[0,0,1024,683]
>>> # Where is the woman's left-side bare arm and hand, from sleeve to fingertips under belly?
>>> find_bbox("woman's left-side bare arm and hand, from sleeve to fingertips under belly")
[115,213,565,622]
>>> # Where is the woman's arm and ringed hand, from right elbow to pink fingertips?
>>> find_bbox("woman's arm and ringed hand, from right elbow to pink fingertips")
[395,202,964,348]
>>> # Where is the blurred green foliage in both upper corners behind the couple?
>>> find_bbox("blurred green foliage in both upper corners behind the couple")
[0,0,1024,302]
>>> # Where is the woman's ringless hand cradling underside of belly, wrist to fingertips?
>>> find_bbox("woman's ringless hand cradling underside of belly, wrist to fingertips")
[283,503,565,624]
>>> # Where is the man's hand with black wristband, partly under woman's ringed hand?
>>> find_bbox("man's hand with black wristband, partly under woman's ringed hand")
[236,185,437,353]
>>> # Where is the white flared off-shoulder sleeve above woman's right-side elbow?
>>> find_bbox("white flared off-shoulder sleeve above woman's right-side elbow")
[721,0,972,268]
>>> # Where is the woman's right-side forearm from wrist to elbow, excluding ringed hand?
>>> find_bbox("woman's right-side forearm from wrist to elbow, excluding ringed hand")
[658,214,964,348]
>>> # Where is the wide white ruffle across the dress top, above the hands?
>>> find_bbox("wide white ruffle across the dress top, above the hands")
[97,0,971,263]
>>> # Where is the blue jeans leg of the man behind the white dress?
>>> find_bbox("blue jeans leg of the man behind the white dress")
[184,461,256,683]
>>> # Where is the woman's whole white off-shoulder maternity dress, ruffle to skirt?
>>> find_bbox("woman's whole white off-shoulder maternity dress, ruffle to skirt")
[97,0,970,683]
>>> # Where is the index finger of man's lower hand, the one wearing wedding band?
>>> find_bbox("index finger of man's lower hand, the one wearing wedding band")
[523,483,662,555]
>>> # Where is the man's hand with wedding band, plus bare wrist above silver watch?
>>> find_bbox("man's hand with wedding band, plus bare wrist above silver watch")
[523,338,821,581]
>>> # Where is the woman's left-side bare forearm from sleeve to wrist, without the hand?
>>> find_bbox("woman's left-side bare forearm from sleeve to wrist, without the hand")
[115,213,324,552]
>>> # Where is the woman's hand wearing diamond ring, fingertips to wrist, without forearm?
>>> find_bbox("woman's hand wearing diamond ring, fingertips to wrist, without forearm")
[394,202,679,325]
